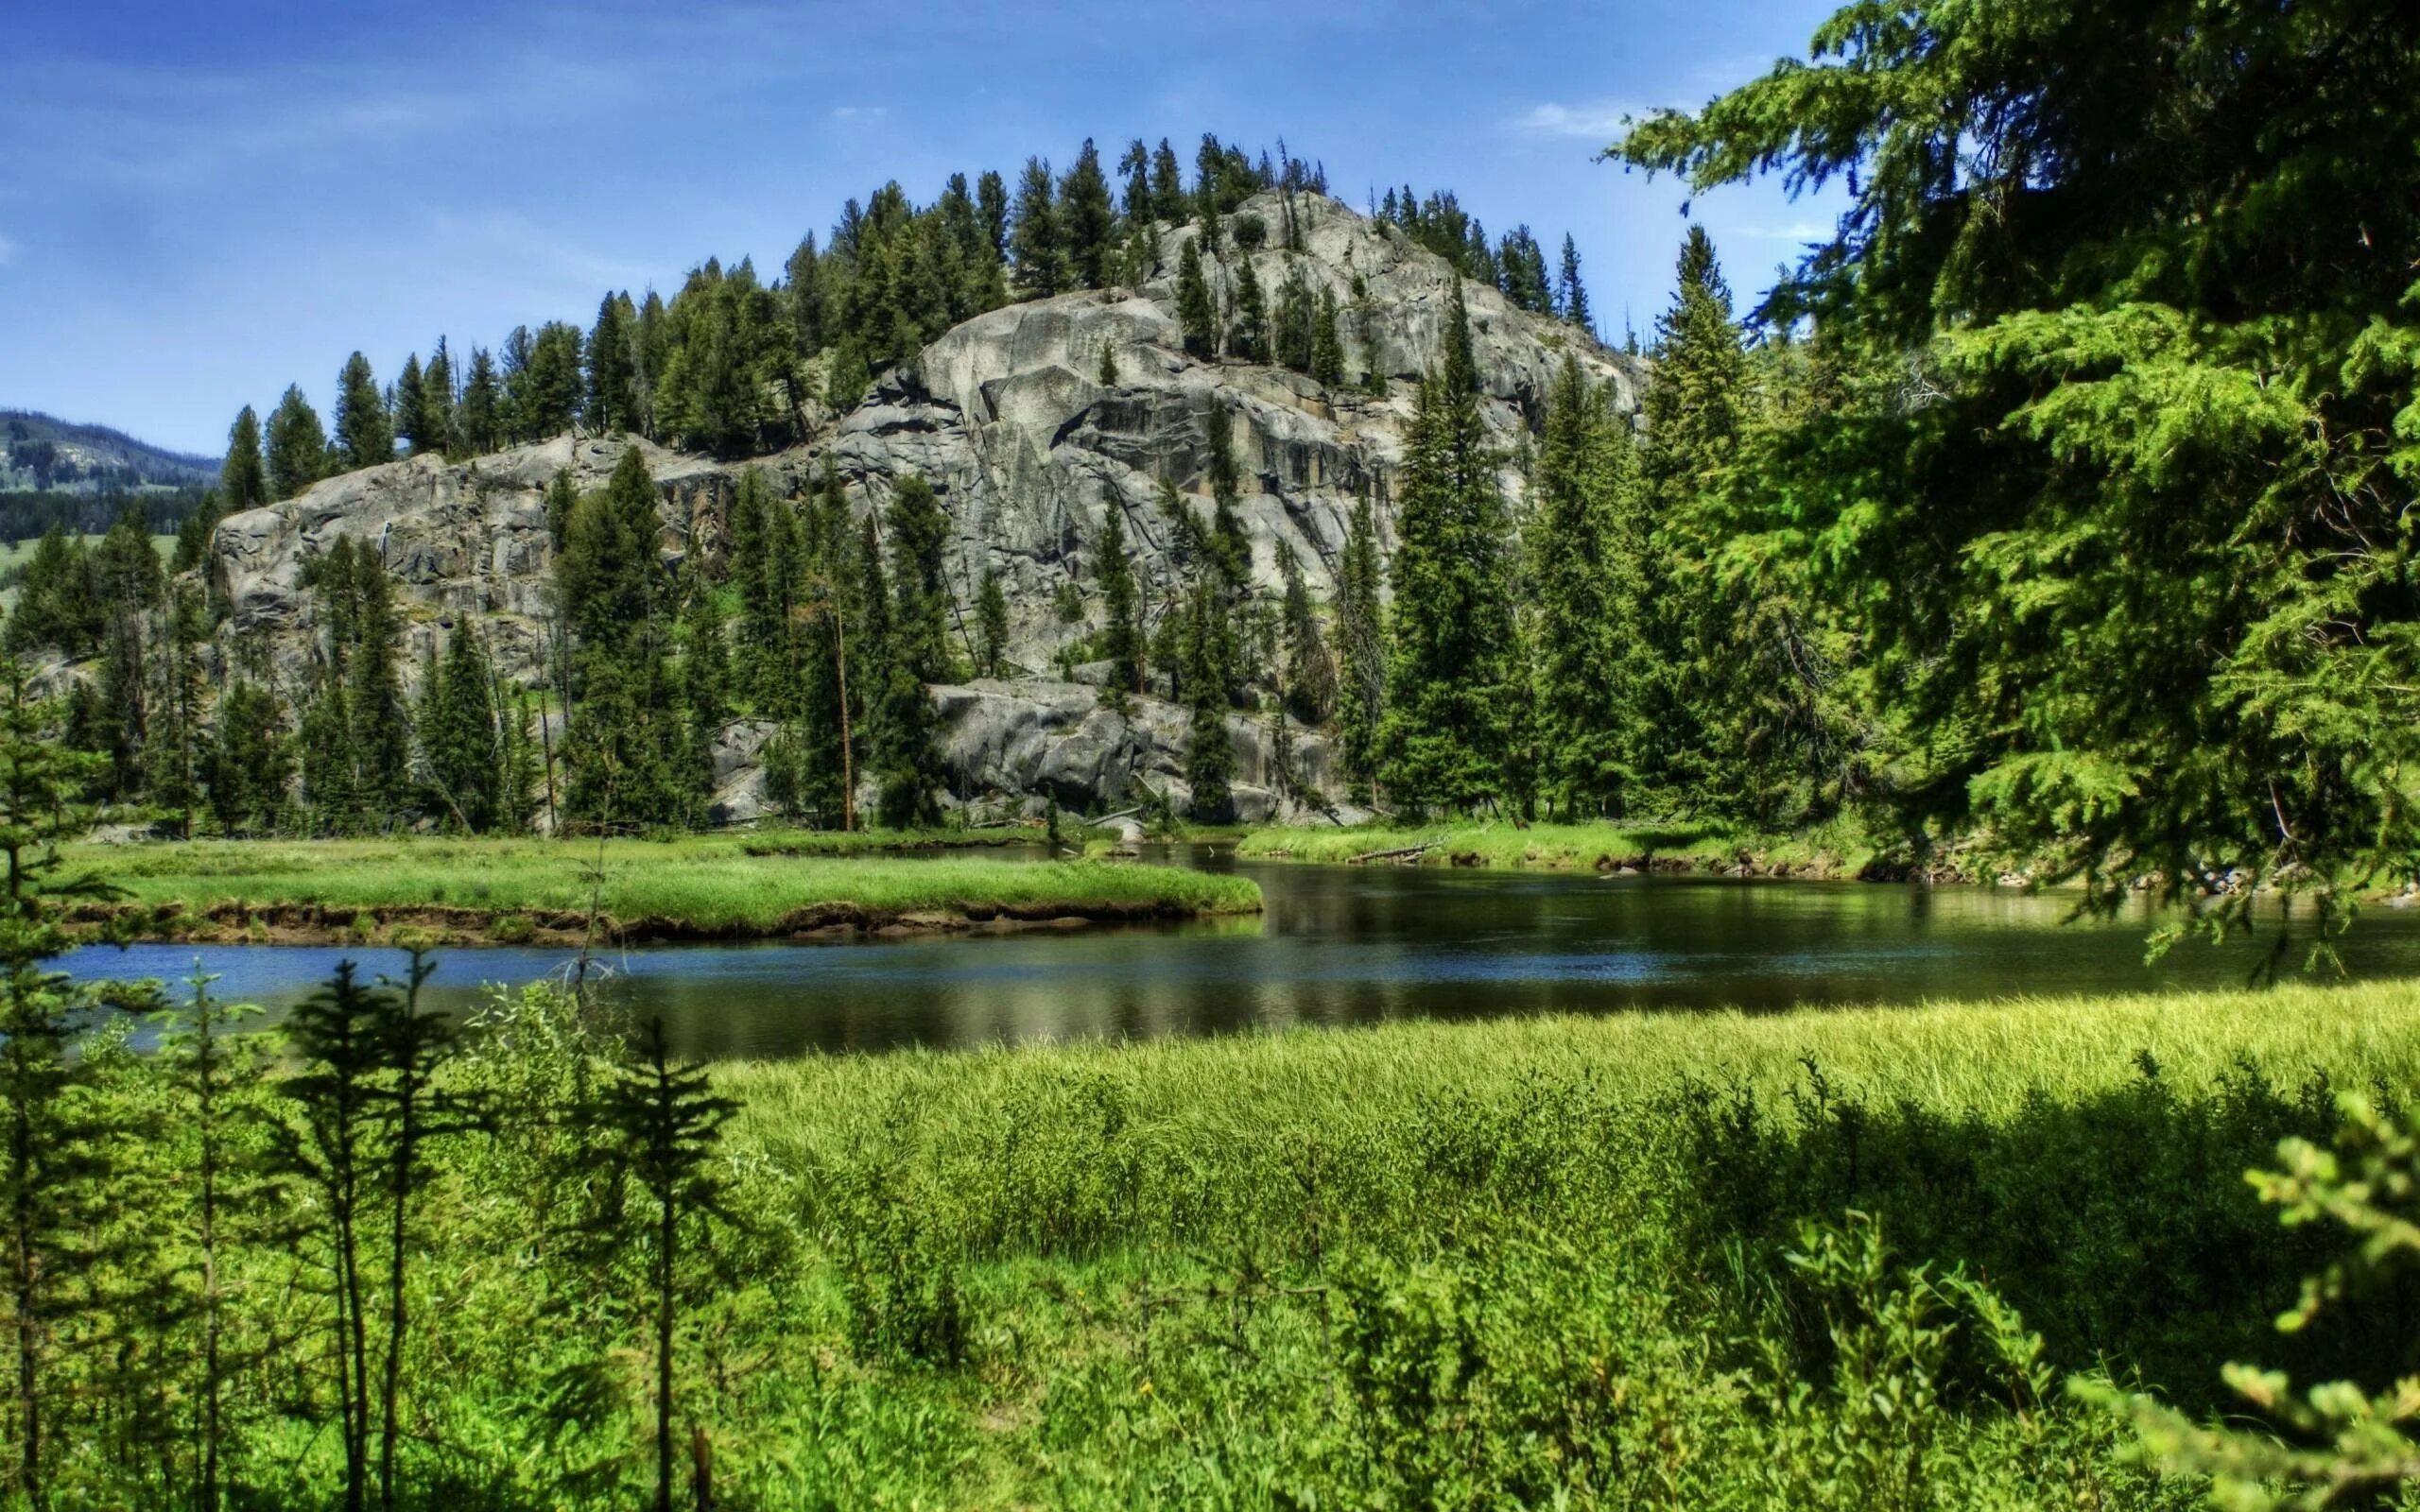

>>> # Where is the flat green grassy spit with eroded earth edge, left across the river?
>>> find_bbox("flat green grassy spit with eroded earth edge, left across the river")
[70,834,1261,943]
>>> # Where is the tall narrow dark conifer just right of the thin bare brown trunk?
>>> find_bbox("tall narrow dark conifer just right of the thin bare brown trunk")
[876,474,951,828]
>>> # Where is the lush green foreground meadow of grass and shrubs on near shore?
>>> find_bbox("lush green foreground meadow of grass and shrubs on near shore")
[46,985,2420,1512]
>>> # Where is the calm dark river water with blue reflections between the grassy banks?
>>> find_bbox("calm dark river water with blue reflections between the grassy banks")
[52,850,2420,1057]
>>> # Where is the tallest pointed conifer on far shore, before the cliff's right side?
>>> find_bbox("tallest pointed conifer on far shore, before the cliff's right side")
[1382,281,1512,811]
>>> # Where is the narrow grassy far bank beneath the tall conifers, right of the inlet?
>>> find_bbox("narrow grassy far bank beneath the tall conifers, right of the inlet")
[1236,820,1905,878]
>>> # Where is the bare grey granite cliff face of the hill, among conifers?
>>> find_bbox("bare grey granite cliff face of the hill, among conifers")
[213,194,1643,827]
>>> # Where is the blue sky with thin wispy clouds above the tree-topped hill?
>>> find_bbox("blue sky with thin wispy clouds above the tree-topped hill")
[0,0,1837,455]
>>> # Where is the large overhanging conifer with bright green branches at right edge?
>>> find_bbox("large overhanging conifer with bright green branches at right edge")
[1615,0,2420,929]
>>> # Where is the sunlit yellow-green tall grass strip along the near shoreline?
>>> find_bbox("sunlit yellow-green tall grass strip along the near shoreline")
[717,980,2420,1144]
